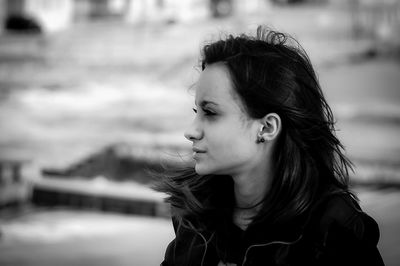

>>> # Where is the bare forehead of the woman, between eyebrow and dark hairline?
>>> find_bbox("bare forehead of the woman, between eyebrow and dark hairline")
[196,64,241,107]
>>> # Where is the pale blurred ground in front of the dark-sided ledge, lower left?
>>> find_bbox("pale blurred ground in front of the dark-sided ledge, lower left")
[0,209,174,266]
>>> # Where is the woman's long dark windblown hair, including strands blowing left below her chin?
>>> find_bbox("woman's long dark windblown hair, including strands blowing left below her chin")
[153,26,352,230]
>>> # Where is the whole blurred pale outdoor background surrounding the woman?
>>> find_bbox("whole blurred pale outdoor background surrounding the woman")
[0,0,400,266]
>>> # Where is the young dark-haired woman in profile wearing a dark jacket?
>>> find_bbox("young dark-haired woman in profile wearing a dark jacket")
[158,27,383,266]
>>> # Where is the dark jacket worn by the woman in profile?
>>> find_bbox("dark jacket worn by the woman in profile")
[161,193,384,266]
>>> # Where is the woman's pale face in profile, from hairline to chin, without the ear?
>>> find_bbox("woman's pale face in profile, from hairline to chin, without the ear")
[185,64,260,175]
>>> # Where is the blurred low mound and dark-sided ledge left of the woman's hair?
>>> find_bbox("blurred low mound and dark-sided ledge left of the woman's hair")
[31,144,179,217]
